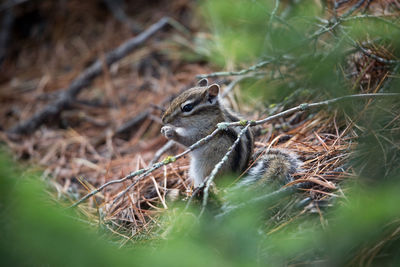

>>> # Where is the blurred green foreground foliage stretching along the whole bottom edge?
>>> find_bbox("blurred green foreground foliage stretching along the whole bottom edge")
[0,153,400,266]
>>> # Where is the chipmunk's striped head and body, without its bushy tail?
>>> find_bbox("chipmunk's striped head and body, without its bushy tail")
[162,81,253,186]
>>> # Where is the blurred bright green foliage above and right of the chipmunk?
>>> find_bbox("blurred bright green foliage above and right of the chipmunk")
[202,0,400,104]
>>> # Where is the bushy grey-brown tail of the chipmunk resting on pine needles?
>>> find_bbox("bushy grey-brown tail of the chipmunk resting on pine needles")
[237,149,302,188]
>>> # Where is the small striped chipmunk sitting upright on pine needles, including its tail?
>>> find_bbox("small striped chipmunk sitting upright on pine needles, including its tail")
[161,79,300,187]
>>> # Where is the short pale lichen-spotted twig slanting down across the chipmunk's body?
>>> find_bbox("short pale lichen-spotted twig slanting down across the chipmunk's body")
[198,123,250,217]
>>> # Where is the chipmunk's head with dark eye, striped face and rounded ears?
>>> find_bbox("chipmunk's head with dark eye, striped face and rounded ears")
[162,79,220,128]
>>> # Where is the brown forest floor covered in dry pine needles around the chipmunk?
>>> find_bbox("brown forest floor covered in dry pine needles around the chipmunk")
[0,0,400,245]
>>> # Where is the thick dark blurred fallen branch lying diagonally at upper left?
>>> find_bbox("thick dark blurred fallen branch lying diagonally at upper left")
[8,17,175,134]
